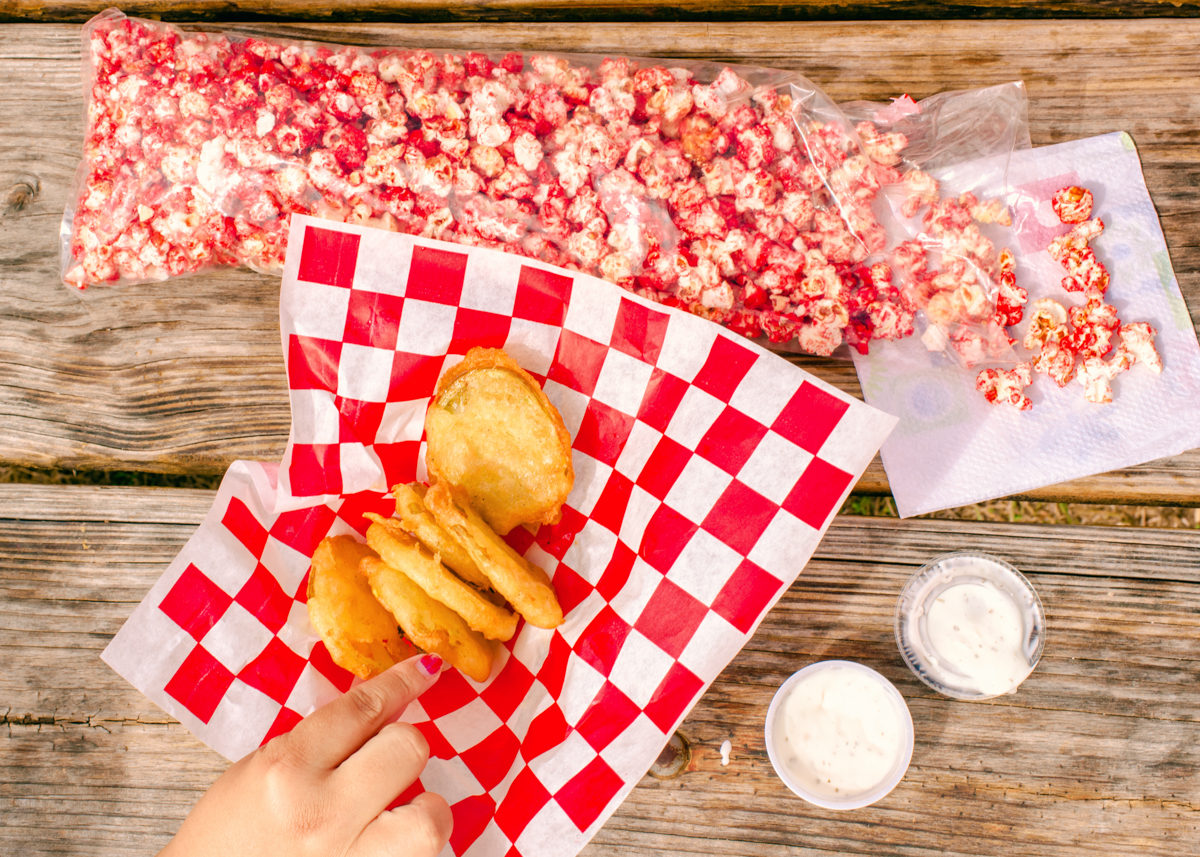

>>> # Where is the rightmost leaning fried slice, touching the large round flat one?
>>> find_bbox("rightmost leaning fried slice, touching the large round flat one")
[425,483,563,628]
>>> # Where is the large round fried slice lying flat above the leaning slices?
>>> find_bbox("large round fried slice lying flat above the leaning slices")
[425,348,575,535]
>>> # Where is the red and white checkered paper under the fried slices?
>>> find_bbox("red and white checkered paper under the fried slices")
[104,216,894,857]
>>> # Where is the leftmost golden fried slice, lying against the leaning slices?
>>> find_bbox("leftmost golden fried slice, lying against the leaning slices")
[308,535,416,678]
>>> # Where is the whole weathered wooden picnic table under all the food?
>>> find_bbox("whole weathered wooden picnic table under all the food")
[0,6,1200,857]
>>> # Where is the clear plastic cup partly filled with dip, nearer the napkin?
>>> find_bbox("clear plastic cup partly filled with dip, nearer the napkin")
[895,551,1045,700]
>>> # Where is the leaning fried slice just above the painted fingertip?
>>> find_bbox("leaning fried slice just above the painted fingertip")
[362,557,497,682]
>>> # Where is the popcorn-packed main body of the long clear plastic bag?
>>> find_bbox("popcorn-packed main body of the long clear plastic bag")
[62,10,1022,354]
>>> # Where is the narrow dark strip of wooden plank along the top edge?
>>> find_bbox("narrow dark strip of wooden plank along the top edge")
[7,0,1200,23]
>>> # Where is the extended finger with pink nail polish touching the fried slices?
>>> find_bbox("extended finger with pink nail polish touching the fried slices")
[284,654,442,771]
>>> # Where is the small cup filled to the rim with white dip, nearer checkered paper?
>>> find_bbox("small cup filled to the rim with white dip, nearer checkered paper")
[766,660,913,809]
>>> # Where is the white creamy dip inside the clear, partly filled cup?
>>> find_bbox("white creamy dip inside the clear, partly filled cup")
[924,580,1032,696]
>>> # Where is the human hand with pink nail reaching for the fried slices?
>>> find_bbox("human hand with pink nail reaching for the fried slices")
[160,654,451,857]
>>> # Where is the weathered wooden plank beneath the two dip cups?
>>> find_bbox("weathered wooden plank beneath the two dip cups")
[0,485,1200,857]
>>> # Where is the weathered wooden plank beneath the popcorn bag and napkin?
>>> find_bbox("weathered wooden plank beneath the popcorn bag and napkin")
[0,20,1200,504]
